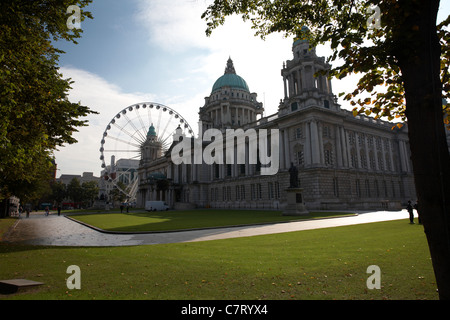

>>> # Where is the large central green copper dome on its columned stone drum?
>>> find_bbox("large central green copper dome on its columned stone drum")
[199,58,264,132]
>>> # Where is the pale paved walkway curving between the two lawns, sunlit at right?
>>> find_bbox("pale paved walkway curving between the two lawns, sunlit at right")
[3,210,416,247]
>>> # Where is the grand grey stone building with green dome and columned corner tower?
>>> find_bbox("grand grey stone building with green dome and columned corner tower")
[137,40,448,210]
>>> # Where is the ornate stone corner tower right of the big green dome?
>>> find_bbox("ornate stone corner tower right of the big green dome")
[279,27,340,114]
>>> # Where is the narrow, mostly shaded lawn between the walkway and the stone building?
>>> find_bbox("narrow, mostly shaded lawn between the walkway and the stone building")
[67,209,353,232]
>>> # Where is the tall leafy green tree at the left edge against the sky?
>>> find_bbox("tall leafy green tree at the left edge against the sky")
[0,0,95,212]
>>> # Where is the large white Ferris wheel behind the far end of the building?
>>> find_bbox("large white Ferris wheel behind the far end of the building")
[100,102,194,202]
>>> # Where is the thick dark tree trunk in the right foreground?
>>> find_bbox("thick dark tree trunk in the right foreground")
[394,0,450,300]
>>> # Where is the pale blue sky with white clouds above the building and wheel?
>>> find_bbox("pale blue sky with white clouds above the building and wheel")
[51,0,450,177]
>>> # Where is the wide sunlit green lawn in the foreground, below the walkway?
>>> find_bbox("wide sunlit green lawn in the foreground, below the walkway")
[0,220,438,300]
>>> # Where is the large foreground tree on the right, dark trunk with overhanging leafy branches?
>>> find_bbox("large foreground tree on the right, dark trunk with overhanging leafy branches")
[202,0,450,299]
